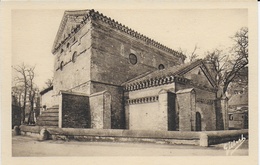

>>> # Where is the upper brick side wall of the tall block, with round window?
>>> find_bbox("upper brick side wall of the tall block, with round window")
[91,20,181,85]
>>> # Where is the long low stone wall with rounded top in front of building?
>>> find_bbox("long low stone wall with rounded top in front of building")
[17,125,248,147]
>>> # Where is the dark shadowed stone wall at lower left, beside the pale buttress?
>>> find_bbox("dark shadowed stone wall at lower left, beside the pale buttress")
[61,92,91,128]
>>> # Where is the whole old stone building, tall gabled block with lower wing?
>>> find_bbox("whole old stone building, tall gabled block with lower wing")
[37,10,225,131]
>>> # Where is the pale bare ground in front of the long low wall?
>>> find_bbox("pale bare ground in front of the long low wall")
[12,136,248,157]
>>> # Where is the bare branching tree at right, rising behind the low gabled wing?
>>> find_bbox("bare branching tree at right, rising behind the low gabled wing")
[205,27,248,97]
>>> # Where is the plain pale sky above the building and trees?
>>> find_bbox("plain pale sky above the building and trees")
[12,8,248,89]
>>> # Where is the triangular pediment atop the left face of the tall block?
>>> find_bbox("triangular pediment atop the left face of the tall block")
[52,10,91,54]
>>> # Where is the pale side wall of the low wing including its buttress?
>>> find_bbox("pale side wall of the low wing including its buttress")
[124,87,178,131]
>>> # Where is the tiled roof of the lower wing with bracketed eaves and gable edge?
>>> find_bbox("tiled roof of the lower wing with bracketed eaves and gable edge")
[122,60,216,91]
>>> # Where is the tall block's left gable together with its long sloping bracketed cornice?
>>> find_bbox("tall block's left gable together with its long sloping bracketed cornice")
[52,9,186,61]
